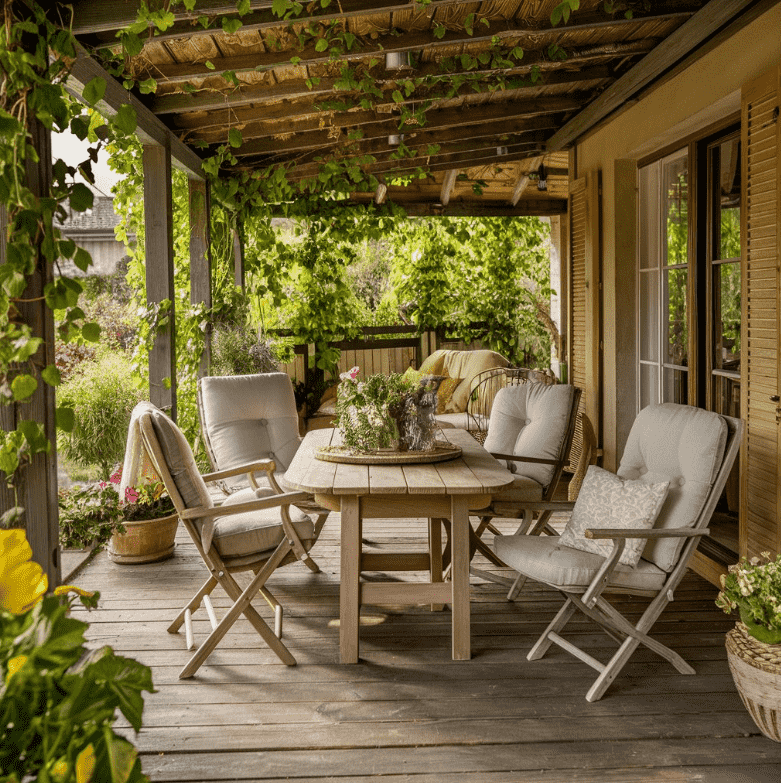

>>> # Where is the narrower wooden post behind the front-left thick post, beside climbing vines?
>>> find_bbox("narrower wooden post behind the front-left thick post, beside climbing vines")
[188,179,212,378]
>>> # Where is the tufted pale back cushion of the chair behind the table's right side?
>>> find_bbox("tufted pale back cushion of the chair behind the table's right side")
[485,383,575,487]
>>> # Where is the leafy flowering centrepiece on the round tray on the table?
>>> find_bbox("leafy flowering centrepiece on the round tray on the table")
[336,367,417,451]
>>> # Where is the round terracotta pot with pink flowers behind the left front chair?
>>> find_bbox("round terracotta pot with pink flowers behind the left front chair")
[108,473,179,563]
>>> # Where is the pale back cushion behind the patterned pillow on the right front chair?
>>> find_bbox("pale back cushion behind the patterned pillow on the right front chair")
[618,403,727,571]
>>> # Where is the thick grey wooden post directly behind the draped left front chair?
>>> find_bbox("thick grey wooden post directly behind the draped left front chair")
[144,144,176,419]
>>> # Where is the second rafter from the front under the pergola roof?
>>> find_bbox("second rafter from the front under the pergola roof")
[138,12,691,83]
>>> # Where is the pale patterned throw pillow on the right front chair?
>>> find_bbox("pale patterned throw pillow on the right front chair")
[561,465,670,568]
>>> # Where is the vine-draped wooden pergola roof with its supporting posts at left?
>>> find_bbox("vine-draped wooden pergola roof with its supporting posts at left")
[3,0,771,583]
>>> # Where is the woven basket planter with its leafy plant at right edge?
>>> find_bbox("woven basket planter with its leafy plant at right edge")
[716,552,781,742]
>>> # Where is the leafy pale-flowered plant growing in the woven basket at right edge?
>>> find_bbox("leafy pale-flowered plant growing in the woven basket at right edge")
[716,552,781,644]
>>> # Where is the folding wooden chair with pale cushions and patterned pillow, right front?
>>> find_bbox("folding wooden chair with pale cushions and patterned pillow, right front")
[494,403,744,701]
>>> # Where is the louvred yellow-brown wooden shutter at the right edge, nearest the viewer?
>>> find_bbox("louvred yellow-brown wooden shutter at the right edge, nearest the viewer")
[740,69,781,557]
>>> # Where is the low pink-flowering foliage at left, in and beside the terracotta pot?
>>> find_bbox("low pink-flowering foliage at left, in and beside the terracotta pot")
[59,470,174,548]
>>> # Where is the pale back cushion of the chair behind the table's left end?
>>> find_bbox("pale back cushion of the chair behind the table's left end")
[199,372,301,471]
